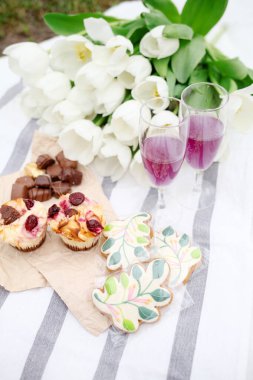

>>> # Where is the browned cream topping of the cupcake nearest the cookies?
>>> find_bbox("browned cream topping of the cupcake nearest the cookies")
[48,194,106,242]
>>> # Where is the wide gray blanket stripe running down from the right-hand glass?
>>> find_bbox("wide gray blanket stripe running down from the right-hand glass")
[167,163,218,380]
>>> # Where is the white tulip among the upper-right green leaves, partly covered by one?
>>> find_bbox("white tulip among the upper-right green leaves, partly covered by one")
[140,25,179,59]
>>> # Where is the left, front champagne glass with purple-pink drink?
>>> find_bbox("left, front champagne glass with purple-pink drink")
[139,97,189,229]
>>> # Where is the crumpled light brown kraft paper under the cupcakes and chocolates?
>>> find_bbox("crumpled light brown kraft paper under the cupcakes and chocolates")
[0,132,115,335]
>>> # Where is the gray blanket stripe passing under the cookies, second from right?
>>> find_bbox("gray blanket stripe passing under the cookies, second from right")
[93,188,158,380]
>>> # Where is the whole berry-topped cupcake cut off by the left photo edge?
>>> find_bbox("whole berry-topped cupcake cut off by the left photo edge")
[0,198,47,252]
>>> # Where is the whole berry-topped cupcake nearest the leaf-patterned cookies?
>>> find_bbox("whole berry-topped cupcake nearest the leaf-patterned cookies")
[48,192,106,251]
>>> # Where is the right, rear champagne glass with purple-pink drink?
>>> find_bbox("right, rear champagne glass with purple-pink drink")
[181,82,229,208]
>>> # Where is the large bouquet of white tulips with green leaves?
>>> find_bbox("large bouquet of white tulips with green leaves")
[4,0,253,183]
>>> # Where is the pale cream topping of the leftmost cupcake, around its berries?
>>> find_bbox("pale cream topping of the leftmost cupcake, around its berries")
[0,198,47,245]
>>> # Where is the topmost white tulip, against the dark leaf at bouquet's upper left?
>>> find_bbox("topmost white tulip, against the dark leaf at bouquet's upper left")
[83,17,114,44]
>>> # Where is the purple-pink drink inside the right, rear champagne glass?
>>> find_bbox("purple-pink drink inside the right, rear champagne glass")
[186,115,224,169]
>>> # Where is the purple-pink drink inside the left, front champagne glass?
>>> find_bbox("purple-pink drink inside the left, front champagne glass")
[142,135,184,186]
